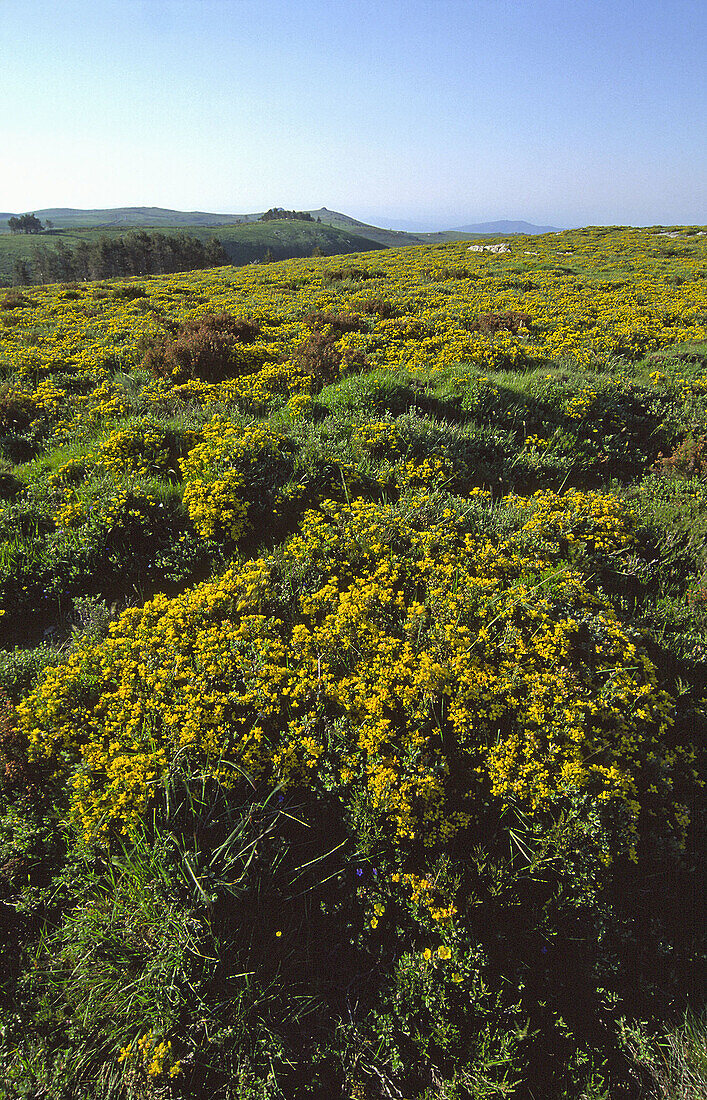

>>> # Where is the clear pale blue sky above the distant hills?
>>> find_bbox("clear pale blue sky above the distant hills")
[0,0,707,229]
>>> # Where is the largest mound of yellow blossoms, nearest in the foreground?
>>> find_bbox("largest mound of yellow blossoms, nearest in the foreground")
[19,494,682,858]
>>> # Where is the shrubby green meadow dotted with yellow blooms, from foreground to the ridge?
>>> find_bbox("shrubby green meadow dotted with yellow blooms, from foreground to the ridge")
[0,223,707,1100]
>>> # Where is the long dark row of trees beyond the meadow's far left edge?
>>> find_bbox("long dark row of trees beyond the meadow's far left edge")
[14,230,230,285]
